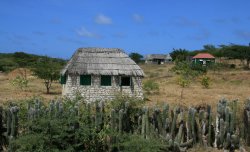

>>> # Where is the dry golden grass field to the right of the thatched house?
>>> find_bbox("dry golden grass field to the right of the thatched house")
[141,65,250,110]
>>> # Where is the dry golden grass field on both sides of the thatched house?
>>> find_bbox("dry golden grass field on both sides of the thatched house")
[0,64,250,107]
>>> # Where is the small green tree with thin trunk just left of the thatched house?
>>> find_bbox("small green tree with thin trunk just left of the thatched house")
[32,57,61,94]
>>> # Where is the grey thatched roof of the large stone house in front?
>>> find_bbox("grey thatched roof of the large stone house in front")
[61,48,144,76]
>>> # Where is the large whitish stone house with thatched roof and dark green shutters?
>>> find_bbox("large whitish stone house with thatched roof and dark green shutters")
[61,48,144,102]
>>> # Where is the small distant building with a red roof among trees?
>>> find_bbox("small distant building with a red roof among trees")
[192,53,215,66]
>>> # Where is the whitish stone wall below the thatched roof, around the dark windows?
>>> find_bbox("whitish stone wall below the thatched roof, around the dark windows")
[62,75,143,102]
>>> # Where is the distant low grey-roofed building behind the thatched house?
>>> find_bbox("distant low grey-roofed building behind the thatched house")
[145,54,172,64]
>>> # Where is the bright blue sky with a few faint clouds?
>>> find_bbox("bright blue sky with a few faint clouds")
[0,0,250,58]
